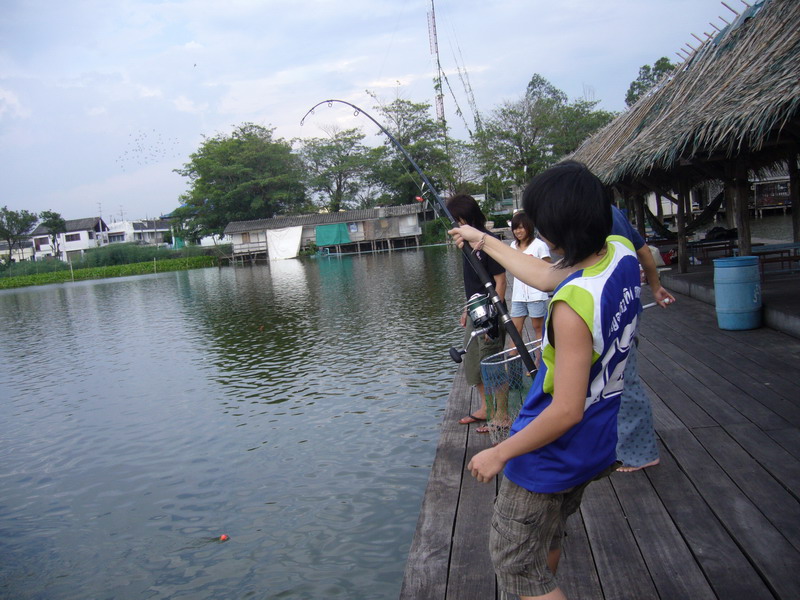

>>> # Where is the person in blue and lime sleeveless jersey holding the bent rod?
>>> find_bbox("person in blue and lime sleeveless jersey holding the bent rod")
[451,162,641,599]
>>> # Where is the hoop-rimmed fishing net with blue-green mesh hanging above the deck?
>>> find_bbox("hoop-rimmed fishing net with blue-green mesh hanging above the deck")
[481,340,540,444]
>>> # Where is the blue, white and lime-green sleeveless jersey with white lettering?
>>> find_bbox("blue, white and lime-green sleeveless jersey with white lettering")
[505,235,641,493]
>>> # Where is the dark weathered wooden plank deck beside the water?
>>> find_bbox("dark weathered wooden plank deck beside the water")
[401,294,800,600]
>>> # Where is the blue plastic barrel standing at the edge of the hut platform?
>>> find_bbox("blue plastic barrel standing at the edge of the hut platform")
[714,256,761,330]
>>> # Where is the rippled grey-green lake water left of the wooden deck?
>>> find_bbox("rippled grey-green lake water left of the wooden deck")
[0,247,463,600]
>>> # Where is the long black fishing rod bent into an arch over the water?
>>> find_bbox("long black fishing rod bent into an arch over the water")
[300,99,536,373]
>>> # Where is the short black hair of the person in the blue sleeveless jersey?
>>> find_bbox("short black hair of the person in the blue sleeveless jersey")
[522,160,612,267]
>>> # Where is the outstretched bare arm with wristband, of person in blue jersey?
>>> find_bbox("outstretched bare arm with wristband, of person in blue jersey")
[448,225,574,292]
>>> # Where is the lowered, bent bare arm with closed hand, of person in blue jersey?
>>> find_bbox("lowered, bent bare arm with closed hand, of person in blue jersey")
[467,302,592,483]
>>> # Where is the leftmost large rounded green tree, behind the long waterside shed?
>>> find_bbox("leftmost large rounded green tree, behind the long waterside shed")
[173,123,307,237]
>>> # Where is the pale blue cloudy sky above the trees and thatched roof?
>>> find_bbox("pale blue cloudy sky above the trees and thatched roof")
[0,0,744,223]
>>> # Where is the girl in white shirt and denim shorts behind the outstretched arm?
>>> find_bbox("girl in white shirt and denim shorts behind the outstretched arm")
[509,211,550,340]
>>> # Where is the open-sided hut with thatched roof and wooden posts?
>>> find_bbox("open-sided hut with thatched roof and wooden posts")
[572,0,800,272]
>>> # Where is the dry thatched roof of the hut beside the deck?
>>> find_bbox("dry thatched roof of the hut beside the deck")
[572,0,800,184]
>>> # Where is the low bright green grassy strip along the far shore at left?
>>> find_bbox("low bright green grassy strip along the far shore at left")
[0,256,218,289]
